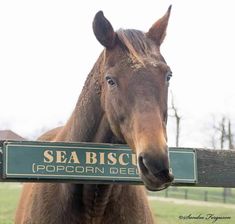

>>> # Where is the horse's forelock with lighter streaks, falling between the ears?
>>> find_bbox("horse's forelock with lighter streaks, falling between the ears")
[116,29,160,66]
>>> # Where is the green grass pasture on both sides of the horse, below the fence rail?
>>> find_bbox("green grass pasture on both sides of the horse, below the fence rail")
[0,183,235,224]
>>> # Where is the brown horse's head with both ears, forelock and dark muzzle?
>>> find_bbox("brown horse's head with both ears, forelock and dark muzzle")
[93,8,173,190]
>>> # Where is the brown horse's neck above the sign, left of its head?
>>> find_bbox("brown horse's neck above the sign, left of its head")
[55,53,113,143]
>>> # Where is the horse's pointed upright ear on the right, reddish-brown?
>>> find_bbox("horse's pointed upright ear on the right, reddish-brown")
[147,5,171,46]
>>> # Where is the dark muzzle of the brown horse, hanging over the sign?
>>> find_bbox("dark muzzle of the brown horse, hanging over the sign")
[138,153,174,191]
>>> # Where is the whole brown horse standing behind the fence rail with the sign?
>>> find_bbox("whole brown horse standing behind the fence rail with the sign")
[15,8,173,224]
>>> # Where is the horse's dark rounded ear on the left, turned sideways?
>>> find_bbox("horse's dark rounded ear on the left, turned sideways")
[93,11,116,48]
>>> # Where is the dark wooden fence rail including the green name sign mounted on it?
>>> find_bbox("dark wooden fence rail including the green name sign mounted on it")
[0,141,235,187]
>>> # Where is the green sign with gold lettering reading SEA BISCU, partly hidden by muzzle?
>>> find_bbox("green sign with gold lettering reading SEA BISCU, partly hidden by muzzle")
[0,141,197,184]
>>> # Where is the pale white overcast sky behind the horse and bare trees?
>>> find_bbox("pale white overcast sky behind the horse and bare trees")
[0,0,235,147]
